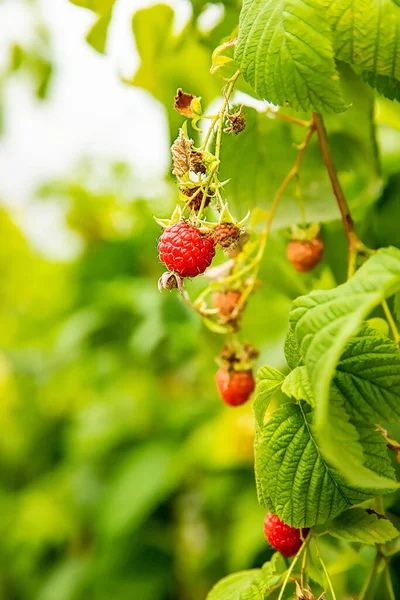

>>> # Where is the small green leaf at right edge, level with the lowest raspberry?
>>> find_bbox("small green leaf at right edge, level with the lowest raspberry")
[327,508,399,544]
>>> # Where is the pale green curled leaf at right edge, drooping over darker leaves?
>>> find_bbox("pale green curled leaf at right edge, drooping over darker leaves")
[290,248,400,488]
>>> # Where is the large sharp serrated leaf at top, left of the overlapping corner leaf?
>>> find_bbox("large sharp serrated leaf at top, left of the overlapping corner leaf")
[235,0,346,112]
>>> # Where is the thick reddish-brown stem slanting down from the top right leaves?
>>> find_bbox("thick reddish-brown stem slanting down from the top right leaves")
[312,113,365,279]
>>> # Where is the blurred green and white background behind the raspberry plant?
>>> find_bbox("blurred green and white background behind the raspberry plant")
[0,0,400,600]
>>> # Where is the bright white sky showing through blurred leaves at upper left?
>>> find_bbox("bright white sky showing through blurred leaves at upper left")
[0,0,190,257]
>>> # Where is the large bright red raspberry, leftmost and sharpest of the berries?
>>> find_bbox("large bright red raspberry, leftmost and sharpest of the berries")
[158,221,215,277]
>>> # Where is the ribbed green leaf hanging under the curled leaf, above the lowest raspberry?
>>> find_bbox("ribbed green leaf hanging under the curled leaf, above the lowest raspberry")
[255,402,393,527]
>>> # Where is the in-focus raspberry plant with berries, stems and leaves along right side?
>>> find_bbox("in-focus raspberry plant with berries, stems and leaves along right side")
[152,0,400,600]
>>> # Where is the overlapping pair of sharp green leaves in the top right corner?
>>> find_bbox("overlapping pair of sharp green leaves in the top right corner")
[235,0,400,113]
